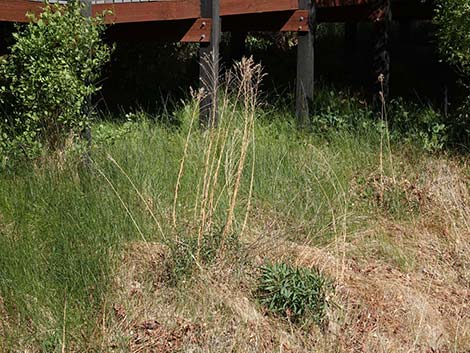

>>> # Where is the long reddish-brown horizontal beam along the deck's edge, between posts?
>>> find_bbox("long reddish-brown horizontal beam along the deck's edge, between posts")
[0,0,434,23]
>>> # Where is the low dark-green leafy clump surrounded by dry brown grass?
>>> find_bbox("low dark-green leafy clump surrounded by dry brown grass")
[258,263,330,325]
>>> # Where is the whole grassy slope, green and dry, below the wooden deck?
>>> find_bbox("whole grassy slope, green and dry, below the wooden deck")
[0,73,470,352]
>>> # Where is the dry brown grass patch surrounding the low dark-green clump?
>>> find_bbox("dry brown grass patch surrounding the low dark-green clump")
[103,157,470,352]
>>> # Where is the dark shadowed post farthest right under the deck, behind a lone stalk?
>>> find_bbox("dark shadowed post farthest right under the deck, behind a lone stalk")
[370,0,392,107]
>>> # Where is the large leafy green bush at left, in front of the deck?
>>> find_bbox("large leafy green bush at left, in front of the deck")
[0,2,110,158]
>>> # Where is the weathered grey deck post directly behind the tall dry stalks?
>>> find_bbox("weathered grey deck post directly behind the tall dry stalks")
[199,0,221,128]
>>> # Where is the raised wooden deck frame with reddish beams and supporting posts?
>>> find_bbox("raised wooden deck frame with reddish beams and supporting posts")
[0,0,432,123]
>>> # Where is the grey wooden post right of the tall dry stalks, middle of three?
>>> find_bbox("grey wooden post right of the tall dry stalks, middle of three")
[295,0,316,127]
